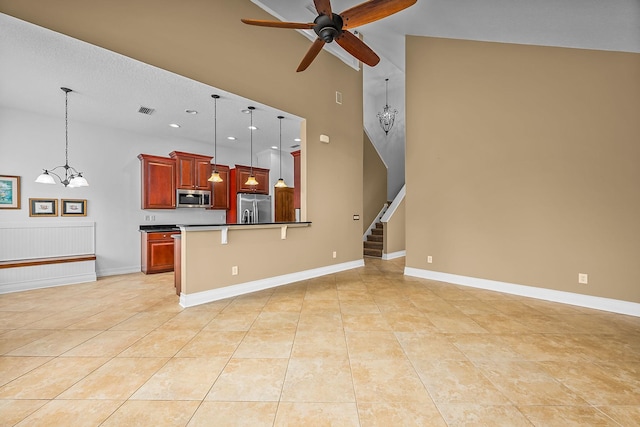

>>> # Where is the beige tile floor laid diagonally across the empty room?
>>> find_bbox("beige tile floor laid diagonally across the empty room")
[0,259,640,427]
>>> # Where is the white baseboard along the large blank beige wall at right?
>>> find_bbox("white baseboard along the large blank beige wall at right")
[404,267,640,317]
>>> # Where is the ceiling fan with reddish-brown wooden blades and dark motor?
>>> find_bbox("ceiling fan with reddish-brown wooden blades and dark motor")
[241,0,418,72]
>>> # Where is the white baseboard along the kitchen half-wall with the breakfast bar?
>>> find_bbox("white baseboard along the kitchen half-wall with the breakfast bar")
[180,259,364,307]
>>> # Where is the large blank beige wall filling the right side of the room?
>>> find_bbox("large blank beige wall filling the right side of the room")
[406,37,640,302]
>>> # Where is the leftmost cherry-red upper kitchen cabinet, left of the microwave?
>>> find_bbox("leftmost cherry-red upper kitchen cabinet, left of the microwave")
[138,154,176,209]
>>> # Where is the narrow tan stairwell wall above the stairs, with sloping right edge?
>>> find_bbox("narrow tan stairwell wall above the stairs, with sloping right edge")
[362,132,387,234]
